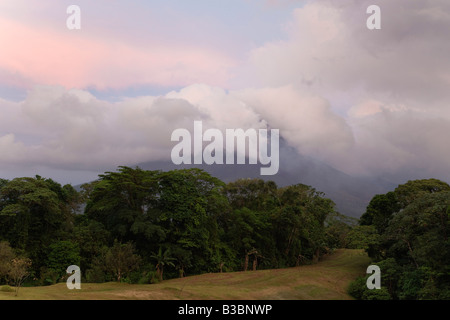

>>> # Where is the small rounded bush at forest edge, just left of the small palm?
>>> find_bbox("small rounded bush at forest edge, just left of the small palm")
[105,240,141,282]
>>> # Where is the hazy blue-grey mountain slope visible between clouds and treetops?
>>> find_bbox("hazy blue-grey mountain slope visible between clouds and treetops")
[138,146,395,218]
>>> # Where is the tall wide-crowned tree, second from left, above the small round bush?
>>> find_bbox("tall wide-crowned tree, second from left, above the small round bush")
[83,166,165,254]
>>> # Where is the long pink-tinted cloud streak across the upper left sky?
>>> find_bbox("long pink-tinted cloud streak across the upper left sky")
[0,17,234,89]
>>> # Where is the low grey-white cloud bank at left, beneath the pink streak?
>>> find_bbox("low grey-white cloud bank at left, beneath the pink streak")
[0,86,196,170]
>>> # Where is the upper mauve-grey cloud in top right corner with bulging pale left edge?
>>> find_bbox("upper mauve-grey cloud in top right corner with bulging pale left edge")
[251,0,450,102]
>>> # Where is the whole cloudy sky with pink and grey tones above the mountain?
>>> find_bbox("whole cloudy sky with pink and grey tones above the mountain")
[0,0,450,184]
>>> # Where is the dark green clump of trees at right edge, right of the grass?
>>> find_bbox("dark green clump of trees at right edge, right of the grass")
[361,179,450,300]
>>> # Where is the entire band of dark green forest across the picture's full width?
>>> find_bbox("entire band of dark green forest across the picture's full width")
[0,167,450,299]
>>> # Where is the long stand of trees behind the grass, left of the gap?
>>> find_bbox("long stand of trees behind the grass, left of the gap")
[0,166,344,285]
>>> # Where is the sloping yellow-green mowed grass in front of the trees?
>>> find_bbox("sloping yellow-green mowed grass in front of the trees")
[0,249,370,300]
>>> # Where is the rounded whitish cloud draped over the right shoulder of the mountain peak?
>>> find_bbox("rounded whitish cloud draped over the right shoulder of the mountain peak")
[238,86,353,160]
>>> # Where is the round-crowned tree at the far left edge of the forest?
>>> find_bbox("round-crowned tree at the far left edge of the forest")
[0,176,80,273]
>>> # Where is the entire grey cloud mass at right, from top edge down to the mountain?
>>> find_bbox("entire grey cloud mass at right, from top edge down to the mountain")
[244,0,450,179]
